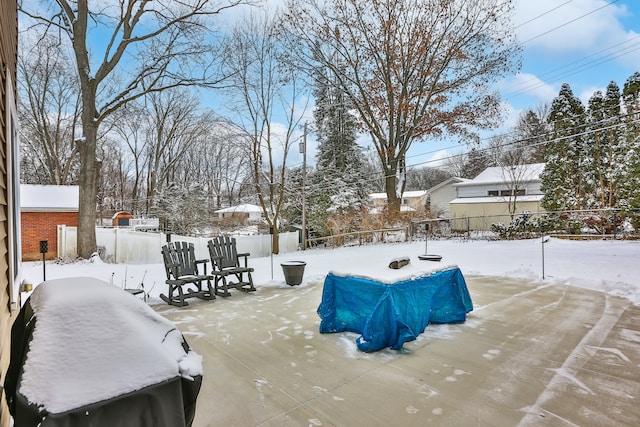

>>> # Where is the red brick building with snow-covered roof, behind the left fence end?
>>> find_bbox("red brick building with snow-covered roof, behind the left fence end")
[20,184,79,261]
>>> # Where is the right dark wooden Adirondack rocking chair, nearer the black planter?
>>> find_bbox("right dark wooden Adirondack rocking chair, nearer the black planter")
[207,236,256,297]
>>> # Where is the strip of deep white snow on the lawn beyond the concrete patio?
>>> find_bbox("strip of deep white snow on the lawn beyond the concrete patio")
[23,238,640,305]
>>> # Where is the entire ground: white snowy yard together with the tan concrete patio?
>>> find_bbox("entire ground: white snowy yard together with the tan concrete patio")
[17,239,640,426]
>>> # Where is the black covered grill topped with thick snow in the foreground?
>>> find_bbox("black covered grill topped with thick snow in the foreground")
[5,277,202,426]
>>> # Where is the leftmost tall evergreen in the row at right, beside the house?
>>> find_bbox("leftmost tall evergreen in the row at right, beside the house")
[541,83,585,211]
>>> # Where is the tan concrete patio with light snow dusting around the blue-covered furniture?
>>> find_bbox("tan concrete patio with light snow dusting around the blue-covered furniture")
[155,275,640,426]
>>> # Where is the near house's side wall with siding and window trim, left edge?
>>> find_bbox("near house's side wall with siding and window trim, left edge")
[0,0,21,427]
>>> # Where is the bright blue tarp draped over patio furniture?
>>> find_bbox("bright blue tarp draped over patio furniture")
[318,268,473,351]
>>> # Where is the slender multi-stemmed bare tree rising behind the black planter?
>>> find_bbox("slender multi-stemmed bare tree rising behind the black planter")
[225,15,305,254]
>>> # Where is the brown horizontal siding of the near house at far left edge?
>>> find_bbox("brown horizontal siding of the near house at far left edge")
[0,0,18,427]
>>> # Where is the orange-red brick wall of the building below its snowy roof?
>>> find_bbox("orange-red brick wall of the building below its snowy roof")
[20,212,78,261]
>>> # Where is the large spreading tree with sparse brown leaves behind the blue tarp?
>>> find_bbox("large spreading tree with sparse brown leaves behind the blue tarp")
[287,0,520,211]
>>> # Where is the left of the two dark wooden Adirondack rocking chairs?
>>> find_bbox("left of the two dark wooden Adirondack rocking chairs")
[160,242,216,307]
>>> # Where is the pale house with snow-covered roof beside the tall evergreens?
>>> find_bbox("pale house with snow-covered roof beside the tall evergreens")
[449,163,544,230]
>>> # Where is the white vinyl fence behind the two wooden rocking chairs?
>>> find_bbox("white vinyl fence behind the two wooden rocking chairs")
[58,225,298,264]
